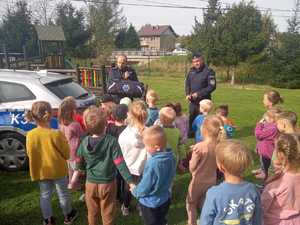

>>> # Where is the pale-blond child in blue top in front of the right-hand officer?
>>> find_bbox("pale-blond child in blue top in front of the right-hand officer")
[192,99,213,143]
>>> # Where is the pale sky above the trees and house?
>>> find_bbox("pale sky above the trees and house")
[0,0,295,35]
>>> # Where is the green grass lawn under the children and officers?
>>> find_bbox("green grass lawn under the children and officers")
[0,76,300,225]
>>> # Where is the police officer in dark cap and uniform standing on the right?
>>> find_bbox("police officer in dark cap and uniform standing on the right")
[185,54,216,137]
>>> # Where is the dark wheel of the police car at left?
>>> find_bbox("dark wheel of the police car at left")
[0,133,28,171]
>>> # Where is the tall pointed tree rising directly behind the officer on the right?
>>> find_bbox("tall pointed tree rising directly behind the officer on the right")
[189,0,222,64]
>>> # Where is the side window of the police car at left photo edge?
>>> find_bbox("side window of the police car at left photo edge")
[0,82,36,102]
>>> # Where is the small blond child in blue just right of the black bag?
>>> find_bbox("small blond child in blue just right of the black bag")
[146,90,159,127]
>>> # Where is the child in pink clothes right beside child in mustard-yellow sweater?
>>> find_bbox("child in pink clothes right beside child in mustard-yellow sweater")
[58,97,83,189]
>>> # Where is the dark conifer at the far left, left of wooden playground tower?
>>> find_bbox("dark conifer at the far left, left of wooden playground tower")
[0,0,38,56]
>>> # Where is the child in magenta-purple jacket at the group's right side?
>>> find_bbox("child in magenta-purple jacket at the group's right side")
[253,109,278,180]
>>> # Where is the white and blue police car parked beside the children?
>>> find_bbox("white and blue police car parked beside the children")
[0,70,96,170]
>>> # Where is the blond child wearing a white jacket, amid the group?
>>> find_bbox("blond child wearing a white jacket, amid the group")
[119,101,148,216]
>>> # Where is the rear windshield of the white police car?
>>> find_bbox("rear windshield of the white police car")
[45,79,89,99]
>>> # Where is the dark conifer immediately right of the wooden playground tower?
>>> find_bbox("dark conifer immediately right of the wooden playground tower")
[55,1,90,57]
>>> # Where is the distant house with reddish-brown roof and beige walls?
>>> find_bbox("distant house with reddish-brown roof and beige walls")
[138,24,178,51]
